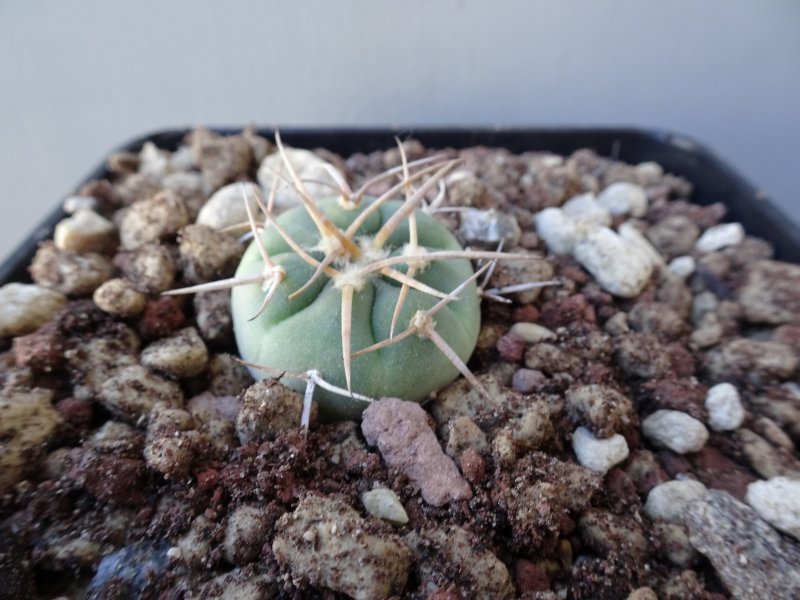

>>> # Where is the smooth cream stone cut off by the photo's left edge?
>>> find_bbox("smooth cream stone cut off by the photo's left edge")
[0,283,67,337]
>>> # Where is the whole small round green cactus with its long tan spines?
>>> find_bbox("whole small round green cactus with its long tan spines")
[172,134,540,425]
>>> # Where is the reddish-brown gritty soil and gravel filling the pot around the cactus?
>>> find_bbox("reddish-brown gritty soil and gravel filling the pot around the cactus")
[0,130,800,600]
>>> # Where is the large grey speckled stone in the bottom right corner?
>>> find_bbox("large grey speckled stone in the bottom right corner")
[687,490,800,598]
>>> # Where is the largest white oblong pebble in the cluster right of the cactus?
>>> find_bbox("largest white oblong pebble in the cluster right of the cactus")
[573,225,653,298]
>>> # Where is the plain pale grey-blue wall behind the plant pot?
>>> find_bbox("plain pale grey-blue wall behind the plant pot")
[0,0,800,256]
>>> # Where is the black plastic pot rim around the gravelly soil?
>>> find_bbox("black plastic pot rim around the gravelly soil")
[0,128,800,284]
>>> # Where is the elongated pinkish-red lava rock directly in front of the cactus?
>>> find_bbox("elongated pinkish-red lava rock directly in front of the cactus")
[361,398,472,506]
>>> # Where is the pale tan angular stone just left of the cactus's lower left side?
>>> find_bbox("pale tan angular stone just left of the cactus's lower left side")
[140,327,208,379]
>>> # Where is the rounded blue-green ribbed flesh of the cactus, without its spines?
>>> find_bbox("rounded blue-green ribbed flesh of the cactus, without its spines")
[232,198,480,419]
